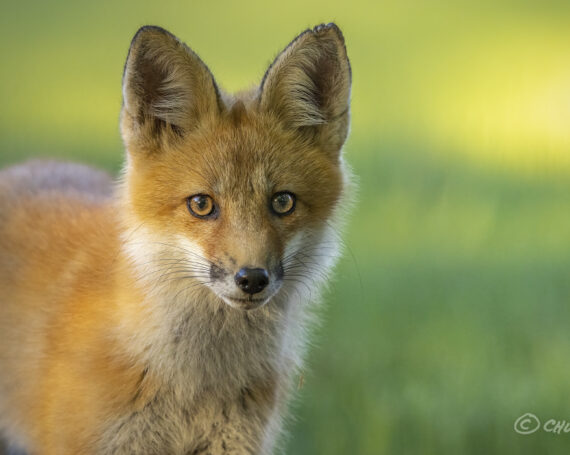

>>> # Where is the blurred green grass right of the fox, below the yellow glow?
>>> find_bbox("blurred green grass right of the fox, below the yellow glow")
[290,144,570,454]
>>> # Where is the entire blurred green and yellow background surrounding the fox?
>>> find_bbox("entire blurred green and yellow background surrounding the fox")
[0,0,570,455]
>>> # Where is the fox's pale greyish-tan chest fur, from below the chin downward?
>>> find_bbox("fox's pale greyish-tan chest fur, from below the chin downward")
[97,296,286,455]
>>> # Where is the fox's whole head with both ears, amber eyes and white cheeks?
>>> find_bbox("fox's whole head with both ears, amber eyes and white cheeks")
[121,24,351,309]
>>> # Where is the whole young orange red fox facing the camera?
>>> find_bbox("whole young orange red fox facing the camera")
[0,23,352,455]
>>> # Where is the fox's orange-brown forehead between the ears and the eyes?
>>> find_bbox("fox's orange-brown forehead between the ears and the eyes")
[138,110,341,210]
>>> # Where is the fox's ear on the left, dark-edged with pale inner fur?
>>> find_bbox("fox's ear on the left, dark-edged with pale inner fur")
[121,26,221,147]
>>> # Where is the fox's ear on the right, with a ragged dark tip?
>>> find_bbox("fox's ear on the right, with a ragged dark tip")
[260,24,351,157]
